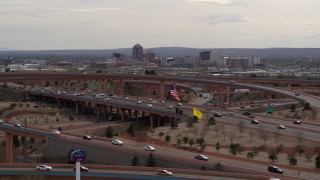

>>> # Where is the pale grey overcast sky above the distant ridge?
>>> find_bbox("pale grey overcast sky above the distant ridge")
[0,0,320,50]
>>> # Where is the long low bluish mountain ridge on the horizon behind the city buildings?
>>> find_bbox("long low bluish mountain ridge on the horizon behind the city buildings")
[0,47,320,59]
